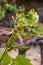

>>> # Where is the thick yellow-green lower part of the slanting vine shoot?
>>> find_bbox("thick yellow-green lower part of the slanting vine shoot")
[0,32,17,63]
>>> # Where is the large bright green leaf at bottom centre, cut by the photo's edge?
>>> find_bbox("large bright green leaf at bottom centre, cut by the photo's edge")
[12,55,32,65]
